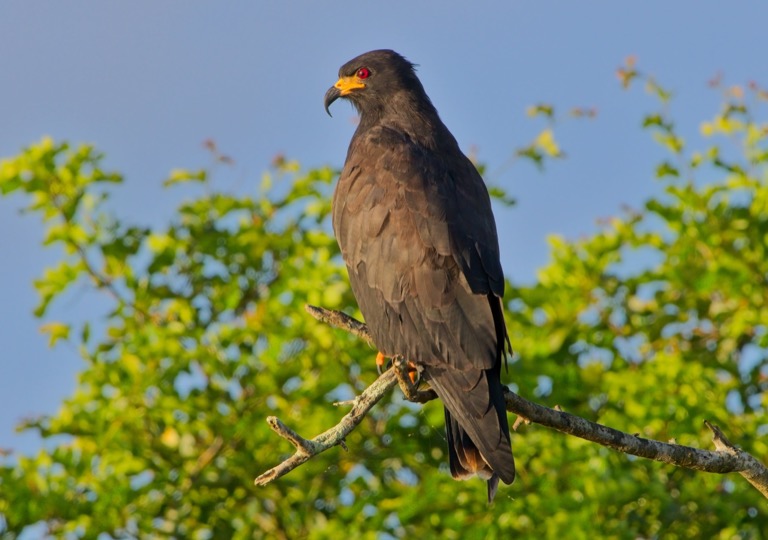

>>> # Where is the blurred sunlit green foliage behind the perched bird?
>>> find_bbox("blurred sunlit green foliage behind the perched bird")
[0,69,768,539]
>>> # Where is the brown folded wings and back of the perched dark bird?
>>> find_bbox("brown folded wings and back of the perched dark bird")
[333,128,504,369]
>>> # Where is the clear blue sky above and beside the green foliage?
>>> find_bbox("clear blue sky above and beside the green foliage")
[0,0,768,451]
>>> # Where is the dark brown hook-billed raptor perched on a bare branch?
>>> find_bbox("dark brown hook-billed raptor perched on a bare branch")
[324,49,515,504]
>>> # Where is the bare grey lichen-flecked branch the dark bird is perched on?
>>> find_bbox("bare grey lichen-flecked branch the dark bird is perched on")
[255,306,768,498]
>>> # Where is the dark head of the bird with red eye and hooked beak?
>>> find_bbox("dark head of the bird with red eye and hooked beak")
[324,50,426,115]
